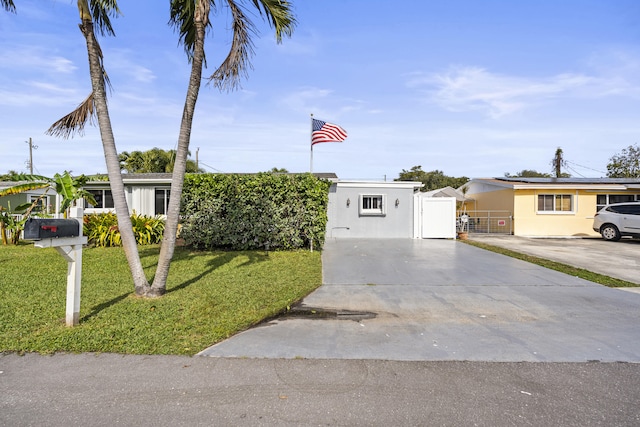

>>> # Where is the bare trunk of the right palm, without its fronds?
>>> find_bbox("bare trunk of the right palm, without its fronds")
[149,1,210,295]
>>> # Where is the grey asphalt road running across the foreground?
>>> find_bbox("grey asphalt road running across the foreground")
[0,354,640,427]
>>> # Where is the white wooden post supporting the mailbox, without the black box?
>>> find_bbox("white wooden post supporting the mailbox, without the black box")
[34,208,87,326]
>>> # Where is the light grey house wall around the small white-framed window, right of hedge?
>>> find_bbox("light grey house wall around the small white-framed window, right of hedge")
[326,182,421,238]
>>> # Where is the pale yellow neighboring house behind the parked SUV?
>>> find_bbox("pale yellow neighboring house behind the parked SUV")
[459,178,640,237]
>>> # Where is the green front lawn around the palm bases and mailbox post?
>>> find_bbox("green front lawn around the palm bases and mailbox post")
[0,244,322,355]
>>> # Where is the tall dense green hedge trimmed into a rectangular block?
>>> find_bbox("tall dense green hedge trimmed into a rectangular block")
[180,173,331,250]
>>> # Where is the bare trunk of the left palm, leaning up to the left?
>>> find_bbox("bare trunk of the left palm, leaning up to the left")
[79,12,149,295]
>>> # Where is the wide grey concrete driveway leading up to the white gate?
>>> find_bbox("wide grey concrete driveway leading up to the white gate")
[200,239,640,362]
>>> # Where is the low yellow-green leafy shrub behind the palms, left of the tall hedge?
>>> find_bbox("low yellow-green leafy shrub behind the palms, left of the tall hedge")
[83,212,164,247]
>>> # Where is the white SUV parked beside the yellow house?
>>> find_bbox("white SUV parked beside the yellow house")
[593,202,640,241]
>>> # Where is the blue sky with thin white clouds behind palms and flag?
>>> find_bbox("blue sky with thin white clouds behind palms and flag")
[0,0,640,180]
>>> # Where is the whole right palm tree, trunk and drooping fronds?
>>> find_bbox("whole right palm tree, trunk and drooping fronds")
[150,0,295,295]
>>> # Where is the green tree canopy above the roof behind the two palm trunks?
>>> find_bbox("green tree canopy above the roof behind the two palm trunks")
[118,148,203,173]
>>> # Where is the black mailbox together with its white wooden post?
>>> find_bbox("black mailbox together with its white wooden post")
[24,208,87,326]
